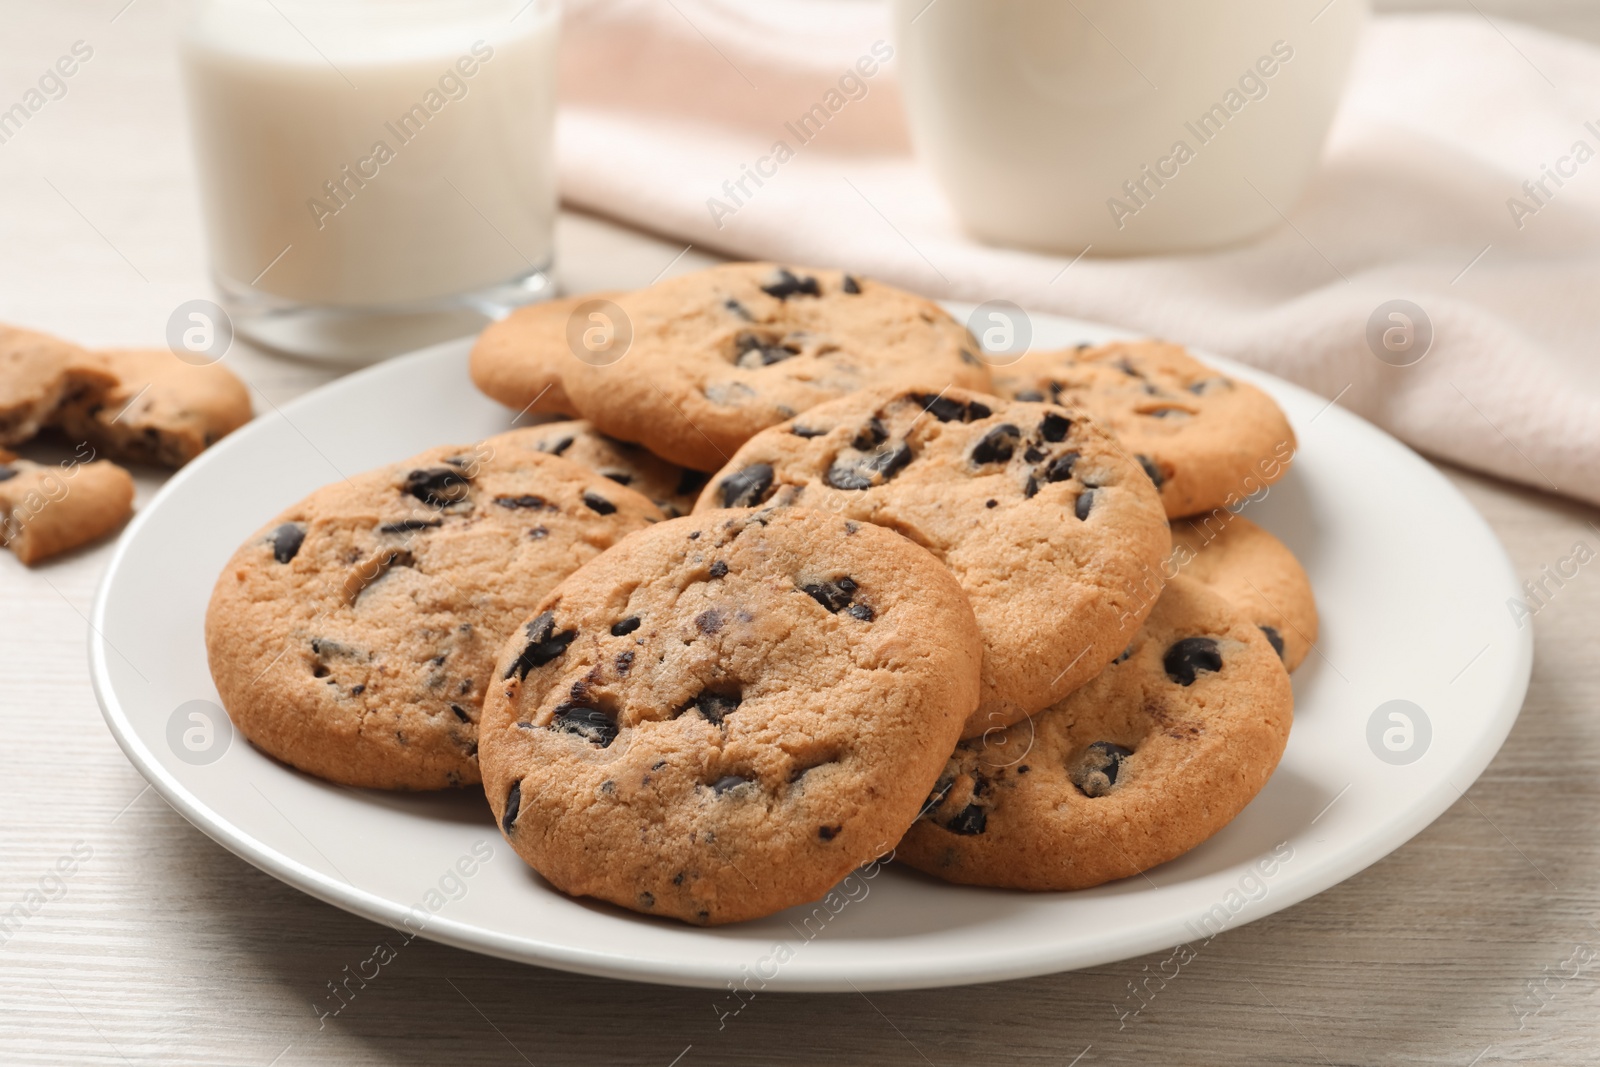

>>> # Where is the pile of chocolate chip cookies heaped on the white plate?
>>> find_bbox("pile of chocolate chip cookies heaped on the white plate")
[206,264,1317,925]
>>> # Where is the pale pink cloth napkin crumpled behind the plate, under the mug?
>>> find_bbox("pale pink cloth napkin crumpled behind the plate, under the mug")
[558,0,1600,502]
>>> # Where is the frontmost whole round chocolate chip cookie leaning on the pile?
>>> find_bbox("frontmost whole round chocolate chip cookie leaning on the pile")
[478,509,978,925]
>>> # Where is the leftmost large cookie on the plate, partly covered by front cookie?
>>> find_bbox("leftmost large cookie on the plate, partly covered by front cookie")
[206,446,661,789]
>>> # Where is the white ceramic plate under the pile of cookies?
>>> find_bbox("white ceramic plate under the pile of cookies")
[90,308,1533,990]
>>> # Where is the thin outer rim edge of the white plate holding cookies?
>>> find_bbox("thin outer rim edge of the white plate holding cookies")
[86,316,1533,992]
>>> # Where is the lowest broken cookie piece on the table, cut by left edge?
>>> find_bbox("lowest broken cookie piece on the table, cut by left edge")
[0,450,133,566]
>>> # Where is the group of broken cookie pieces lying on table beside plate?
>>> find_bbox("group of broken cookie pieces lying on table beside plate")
[0,323,250,565]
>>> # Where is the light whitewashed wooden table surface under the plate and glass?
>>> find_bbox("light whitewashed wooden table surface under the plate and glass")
[0,0,1600,1067]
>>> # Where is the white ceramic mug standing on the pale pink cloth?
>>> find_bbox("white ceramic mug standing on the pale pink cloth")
[894,0,1366,256]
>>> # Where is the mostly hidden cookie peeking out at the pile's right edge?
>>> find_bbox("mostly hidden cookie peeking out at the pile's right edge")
[1173,510,1317,670]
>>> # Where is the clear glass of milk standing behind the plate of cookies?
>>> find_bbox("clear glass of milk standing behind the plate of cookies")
[182,0,560,362]
